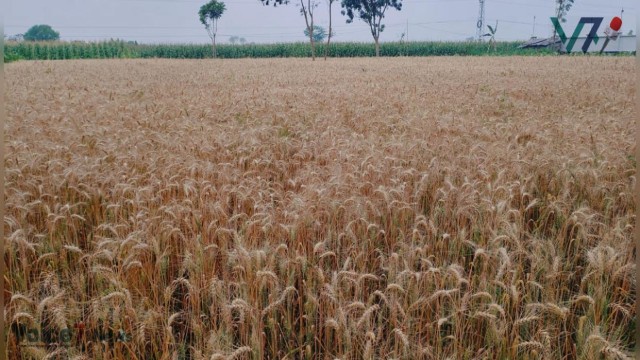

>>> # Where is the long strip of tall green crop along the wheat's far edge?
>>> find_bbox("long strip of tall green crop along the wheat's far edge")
[4,41,554,62]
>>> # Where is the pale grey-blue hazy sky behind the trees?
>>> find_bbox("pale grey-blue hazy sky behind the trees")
[4,0,638,43]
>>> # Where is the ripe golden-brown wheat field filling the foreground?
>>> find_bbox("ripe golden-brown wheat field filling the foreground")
[4,57,637,360]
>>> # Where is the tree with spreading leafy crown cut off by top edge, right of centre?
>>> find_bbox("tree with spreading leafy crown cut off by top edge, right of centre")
[342,0,402,56]
